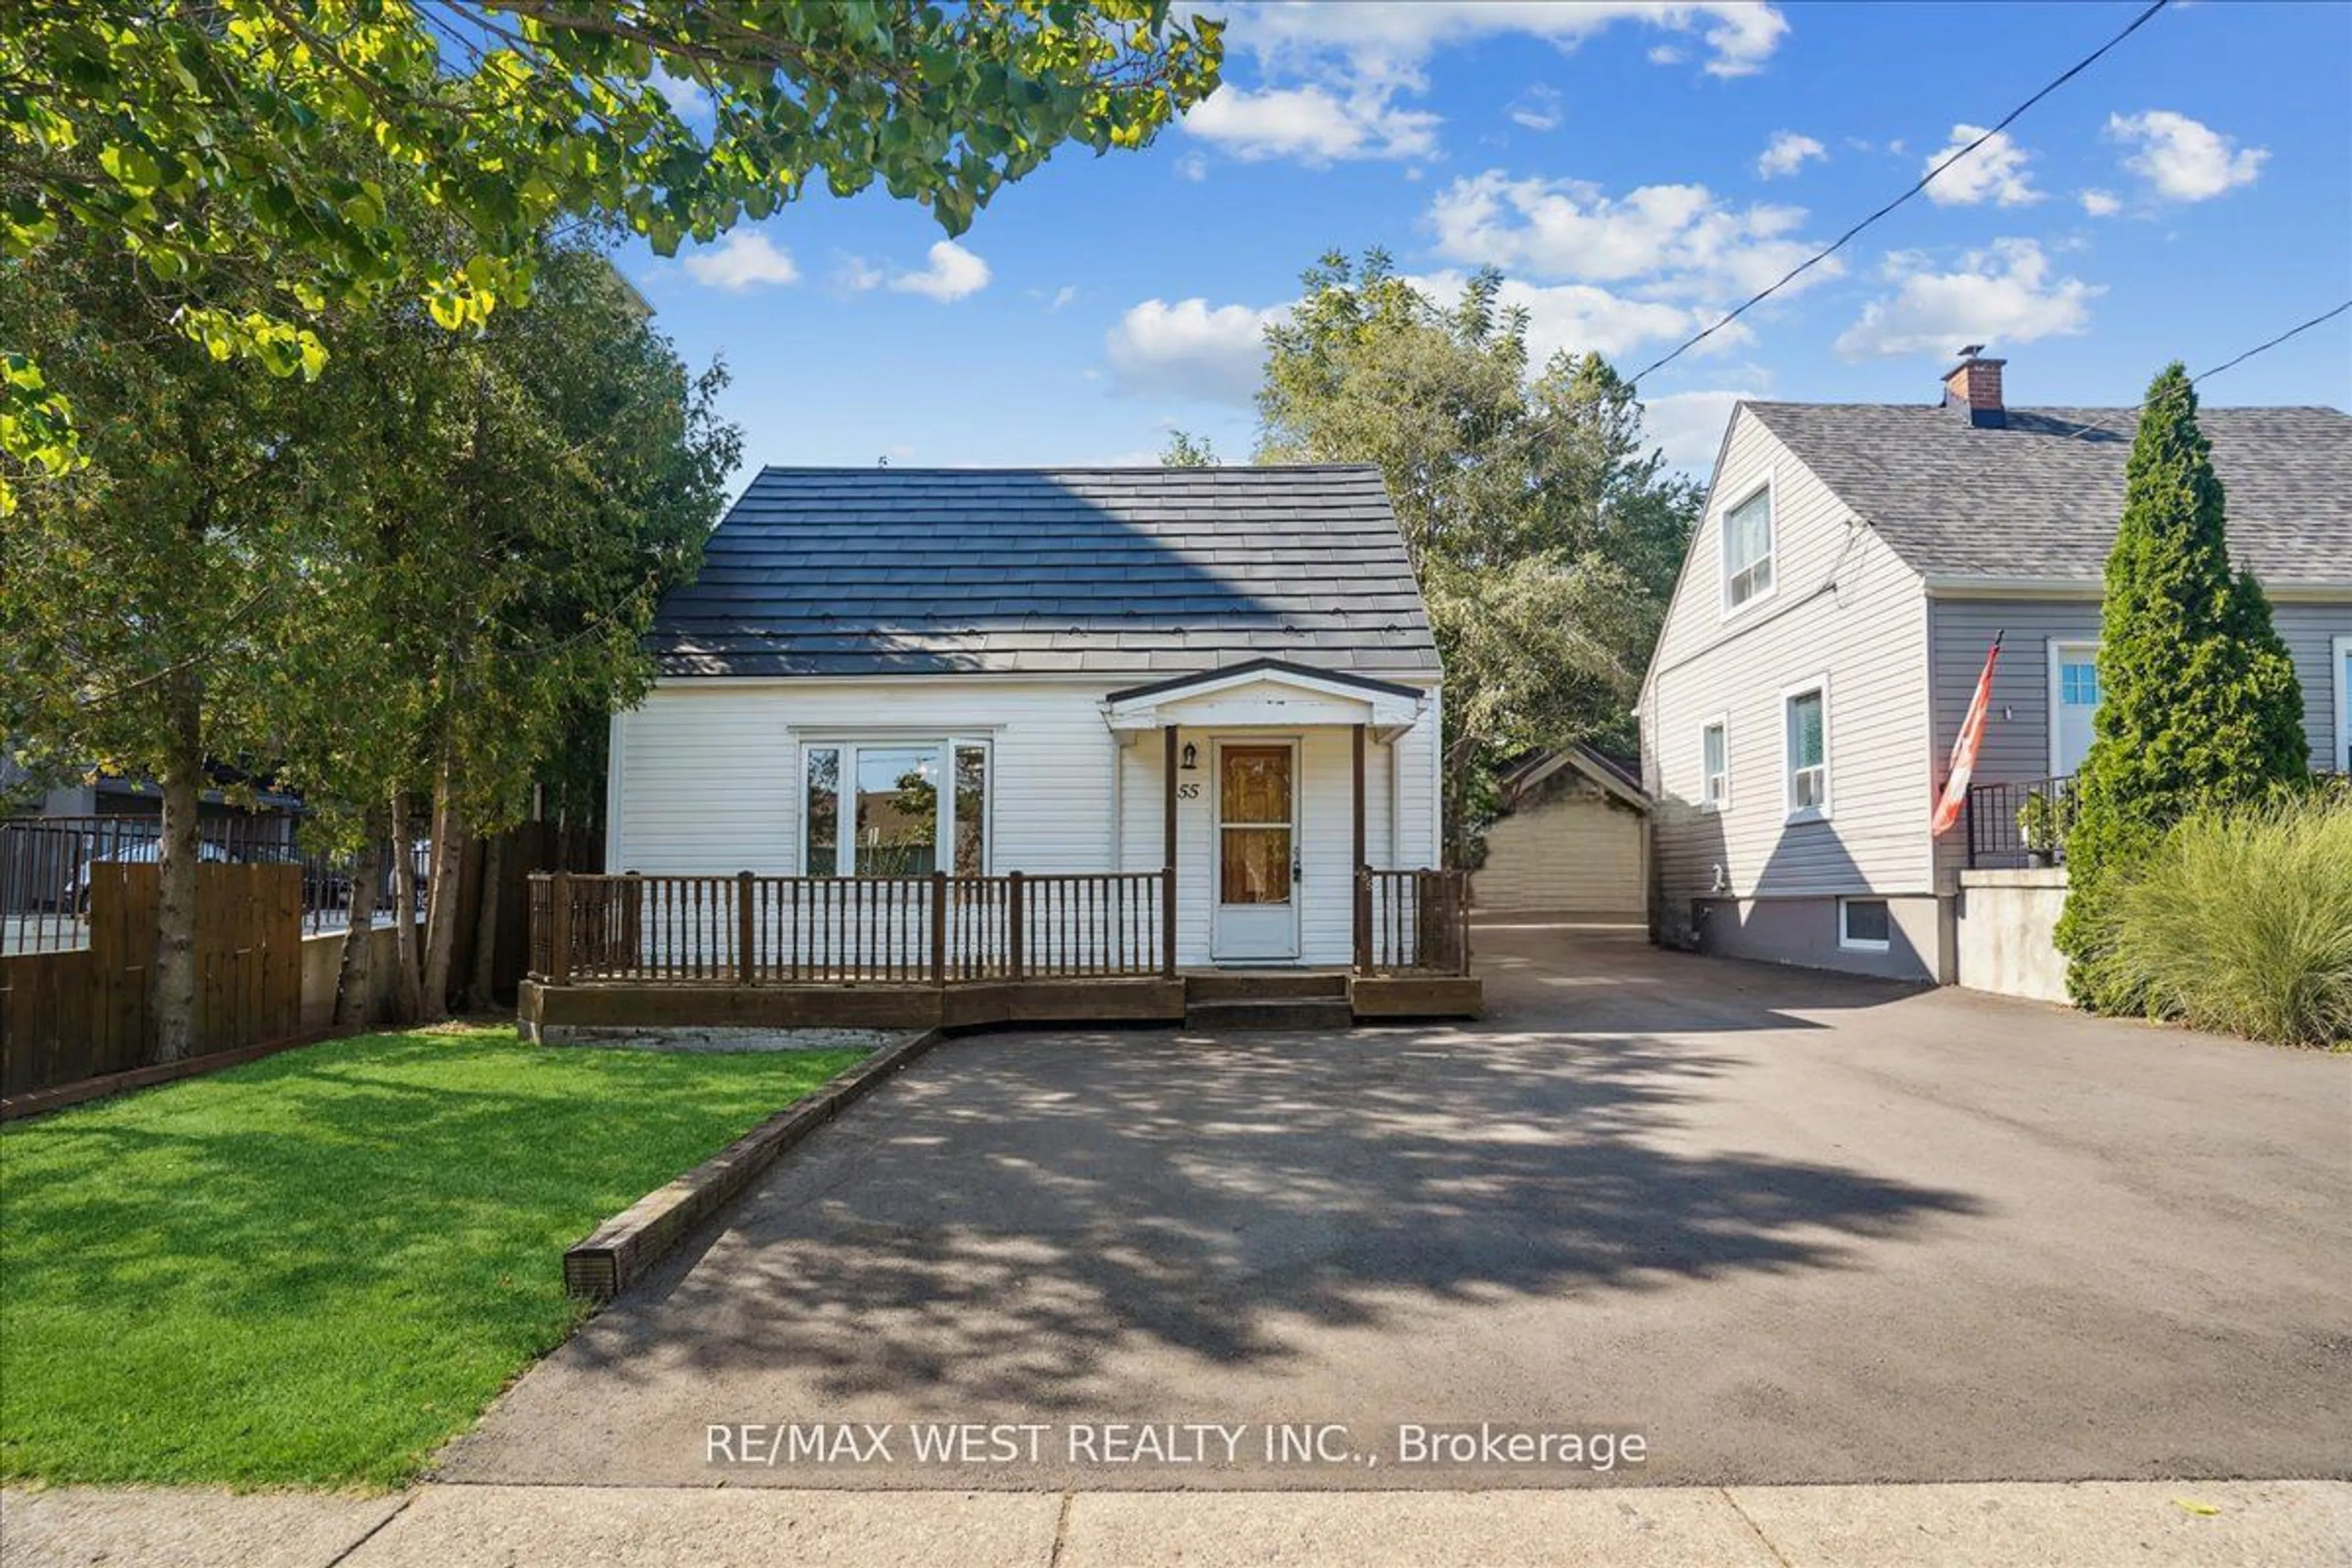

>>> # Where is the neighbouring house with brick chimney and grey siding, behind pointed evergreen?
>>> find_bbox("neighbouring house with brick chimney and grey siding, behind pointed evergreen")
[1639,360,2352,980]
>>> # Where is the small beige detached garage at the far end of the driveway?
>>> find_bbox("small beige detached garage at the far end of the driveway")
[1470,745,1649,922]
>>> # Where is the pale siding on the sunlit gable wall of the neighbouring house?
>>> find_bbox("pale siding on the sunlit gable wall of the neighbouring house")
[1642,409,1933,912]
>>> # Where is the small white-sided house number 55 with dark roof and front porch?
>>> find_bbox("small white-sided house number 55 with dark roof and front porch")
[543,466,1475,1020]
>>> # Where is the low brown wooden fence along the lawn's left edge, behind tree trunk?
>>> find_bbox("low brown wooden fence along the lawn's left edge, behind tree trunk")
[0,863,303,1096]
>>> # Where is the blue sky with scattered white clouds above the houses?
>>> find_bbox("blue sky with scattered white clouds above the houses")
[621,0,2352,486]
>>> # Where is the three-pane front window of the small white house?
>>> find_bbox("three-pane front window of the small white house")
[802,741,988,877]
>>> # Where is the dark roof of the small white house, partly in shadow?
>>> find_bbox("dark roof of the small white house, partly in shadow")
[649,466,1437,682]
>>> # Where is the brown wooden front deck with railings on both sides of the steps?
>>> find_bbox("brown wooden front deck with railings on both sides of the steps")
[518,867,1482,1039]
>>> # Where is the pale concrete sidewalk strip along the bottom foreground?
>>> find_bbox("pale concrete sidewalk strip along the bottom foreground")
[0,1481,2352,1568]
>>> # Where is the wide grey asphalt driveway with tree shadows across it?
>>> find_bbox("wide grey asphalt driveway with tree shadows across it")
[442,929,2352,1488]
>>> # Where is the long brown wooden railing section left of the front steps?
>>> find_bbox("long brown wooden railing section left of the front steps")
[532,872,1176,985]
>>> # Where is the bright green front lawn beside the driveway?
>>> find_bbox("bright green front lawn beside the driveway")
[0,1027,861,1486]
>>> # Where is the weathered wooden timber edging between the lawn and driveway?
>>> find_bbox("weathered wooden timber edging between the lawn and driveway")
[565,1030,941,1302]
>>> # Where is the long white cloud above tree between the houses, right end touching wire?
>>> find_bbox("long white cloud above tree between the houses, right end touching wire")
[1428,169,1839,298]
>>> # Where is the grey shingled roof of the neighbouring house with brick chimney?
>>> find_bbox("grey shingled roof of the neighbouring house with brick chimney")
[1747,402,2352,586]
